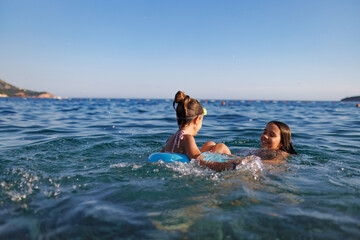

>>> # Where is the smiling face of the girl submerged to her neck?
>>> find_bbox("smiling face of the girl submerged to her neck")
[260,123,282,150]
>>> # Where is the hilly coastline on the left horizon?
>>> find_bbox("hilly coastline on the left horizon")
[0,79,56,98]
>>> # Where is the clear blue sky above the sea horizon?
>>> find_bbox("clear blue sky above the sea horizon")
[0,0,360,100]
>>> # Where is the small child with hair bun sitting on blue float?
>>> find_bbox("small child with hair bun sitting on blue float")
[160,91,231,160]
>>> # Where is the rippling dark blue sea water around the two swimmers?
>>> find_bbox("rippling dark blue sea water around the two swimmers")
[0,98,360,239]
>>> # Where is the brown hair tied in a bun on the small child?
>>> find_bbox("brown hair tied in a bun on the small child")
[173,91,204,127]
